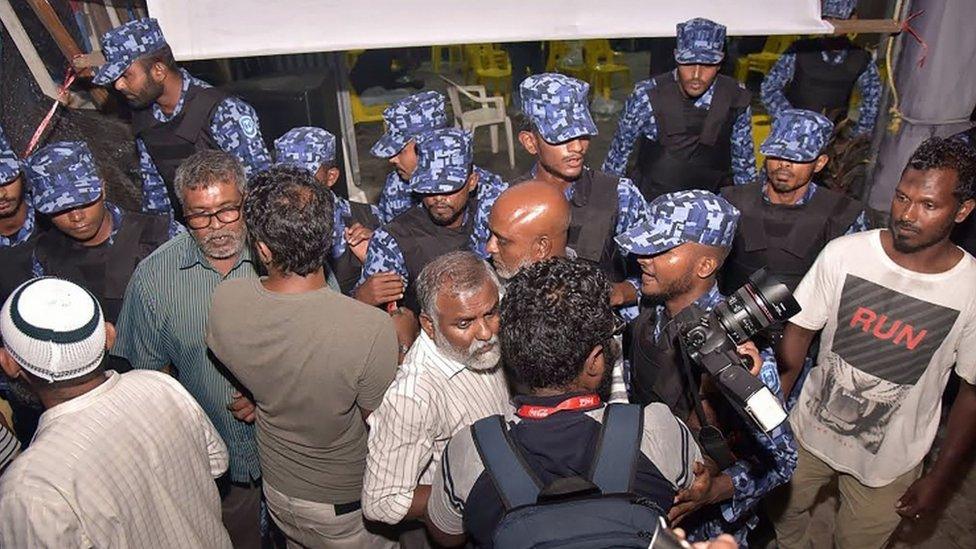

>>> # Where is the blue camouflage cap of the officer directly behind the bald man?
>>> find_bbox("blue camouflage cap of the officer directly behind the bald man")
[519,72,598,143]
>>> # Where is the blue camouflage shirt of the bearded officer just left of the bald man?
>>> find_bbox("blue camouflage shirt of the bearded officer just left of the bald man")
[357,166,508,286]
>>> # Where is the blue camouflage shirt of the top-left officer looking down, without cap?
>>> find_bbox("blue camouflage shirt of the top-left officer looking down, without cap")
[136,69,271,212]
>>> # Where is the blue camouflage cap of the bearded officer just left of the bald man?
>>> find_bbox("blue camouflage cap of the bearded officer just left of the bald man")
[410,128,472,194]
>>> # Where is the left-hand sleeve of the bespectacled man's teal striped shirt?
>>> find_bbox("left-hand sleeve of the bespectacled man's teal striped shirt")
[111,263,171,370]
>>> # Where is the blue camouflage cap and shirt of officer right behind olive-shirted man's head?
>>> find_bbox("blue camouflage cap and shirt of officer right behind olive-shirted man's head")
[275,126,380,258]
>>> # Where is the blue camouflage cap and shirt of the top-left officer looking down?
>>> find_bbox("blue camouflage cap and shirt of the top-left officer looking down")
[92,17,271,213]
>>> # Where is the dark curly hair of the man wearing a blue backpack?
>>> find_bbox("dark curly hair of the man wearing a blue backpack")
[499,258,614,391]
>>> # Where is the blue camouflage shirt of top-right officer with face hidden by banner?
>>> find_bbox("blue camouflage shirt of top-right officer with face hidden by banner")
[759,50,881,136]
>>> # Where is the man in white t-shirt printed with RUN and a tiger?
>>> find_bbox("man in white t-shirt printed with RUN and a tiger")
[772,138,976,549]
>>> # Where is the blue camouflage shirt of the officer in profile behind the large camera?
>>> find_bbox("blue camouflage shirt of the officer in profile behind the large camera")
[654,284,797,547]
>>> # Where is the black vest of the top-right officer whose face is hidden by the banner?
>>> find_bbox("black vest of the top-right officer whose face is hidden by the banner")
[784,38,871,123]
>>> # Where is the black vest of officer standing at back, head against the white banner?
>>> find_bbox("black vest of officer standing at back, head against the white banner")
[632,72,751,202]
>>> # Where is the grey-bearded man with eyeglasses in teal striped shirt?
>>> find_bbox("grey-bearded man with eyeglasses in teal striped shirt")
[111,150,261,548]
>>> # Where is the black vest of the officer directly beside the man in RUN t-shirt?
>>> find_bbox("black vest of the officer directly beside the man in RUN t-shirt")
[719,183,862,295]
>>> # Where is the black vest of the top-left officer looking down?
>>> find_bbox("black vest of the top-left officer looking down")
[132,84,229,221]
